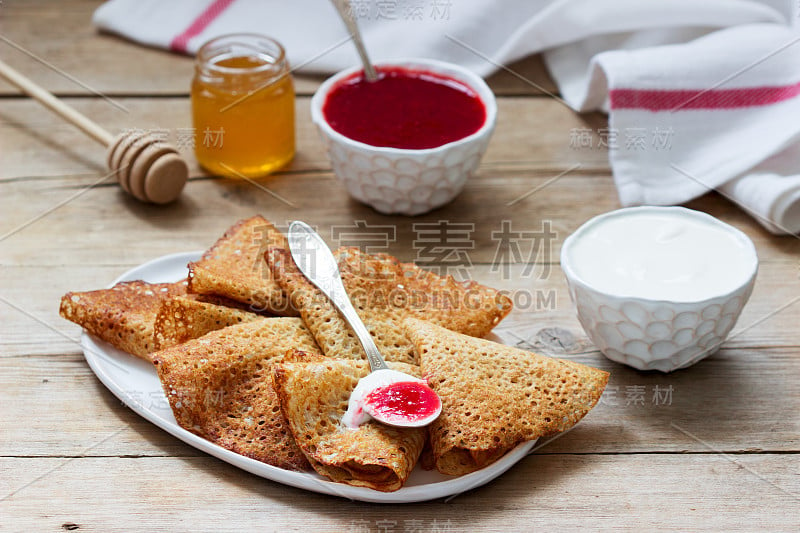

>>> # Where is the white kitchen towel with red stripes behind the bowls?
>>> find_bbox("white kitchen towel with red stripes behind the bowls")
[94,0,800,233]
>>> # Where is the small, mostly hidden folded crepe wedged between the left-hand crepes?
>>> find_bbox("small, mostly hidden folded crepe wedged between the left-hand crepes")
[154,294,263,351]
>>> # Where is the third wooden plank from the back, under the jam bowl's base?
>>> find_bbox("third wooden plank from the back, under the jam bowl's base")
[0,168,800,268]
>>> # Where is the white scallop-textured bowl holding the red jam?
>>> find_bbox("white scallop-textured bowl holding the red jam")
[311,59,497,215]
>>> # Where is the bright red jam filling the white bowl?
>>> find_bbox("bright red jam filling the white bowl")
[322,67,486,150]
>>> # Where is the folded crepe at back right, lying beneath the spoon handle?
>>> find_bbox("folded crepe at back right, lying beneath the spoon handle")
[266,247,511,364]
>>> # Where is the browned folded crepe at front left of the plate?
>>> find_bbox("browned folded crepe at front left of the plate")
[153,317,319,470]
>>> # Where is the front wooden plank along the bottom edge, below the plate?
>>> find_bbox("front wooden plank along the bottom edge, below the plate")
[0,454,800,532]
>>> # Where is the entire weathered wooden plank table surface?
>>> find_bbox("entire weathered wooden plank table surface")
[0,0,800,531]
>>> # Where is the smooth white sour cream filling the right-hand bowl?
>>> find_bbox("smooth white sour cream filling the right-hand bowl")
[562,207,758,302]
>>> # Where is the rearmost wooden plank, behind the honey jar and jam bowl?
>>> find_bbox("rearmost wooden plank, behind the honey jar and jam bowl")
[0,0,557,97]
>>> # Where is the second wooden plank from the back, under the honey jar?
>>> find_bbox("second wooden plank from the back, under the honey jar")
[0,97,608,179]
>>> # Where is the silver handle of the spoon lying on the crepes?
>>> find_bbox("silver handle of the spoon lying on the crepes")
[289,220,389,372]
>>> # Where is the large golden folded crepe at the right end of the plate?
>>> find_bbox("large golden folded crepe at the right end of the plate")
[405,319,608,475]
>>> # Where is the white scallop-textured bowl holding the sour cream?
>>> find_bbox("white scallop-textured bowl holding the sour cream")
[561,207,758,372]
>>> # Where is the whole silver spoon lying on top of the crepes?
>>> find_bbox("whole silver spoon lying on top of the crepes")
[289,220,442,427]
